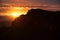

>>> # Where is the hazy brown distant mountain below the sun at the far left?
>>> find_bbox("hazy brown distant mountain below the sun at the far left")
[0,16,12,28]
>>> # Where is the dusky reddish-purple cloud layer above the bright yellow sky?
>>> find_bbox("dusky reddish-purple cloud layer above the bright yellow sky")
[0,0,60,10]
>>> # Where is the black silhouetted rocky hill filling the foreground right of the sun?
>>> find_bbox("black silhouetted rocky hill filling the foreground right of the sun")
[0,9,60,40]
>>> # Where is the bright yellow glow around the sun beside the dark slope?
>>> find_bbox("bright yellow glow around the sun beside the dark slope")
[6,7,28,19]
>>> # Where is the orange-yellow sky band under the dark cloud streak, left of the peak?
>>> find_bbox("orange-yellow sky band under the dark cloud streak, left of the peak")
[0,7,29,20]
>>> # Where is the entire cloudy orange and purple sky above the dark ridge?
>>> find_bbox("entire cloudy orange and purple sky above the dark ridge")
[0,0,60,16]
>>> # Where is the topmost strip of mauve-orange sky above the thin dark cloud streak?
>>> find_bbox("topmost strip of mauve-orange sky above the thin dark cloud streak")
[0,0,60,6]
